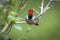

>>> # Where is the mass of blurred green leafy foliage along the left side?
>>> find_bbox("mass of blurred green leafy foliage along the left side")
[0,0,26,38]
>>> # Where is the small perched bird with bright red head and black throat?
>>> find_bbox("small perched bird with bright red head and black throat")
[25,10,39,25]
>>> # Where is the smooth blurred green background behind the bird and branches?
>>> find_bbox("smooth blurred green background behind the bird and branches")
[0,0,60,40]
